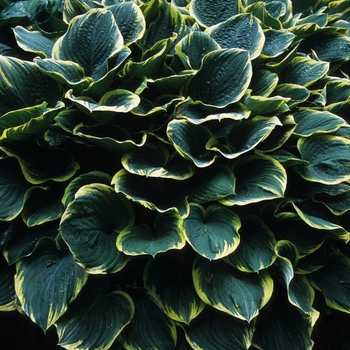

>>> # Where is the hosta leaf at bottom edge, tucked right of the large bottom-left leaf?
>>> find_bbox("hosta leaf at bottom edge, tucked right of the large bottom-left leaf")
[56,290,135,350]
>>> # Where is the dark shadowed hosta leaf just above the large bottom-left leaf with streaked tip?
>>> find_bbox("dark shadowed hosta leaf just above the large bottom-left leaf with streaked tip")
[3,224,58,265]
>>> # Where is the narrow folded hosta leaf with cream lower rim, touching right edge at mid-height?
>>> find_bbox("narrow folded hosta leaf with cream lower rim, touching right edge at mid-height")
[292,202,350,243]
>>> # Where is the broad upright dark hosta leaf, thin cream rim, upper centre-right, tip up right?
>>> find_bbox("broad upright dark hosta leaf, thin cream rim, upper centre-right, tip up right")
[187,49,252,107]
